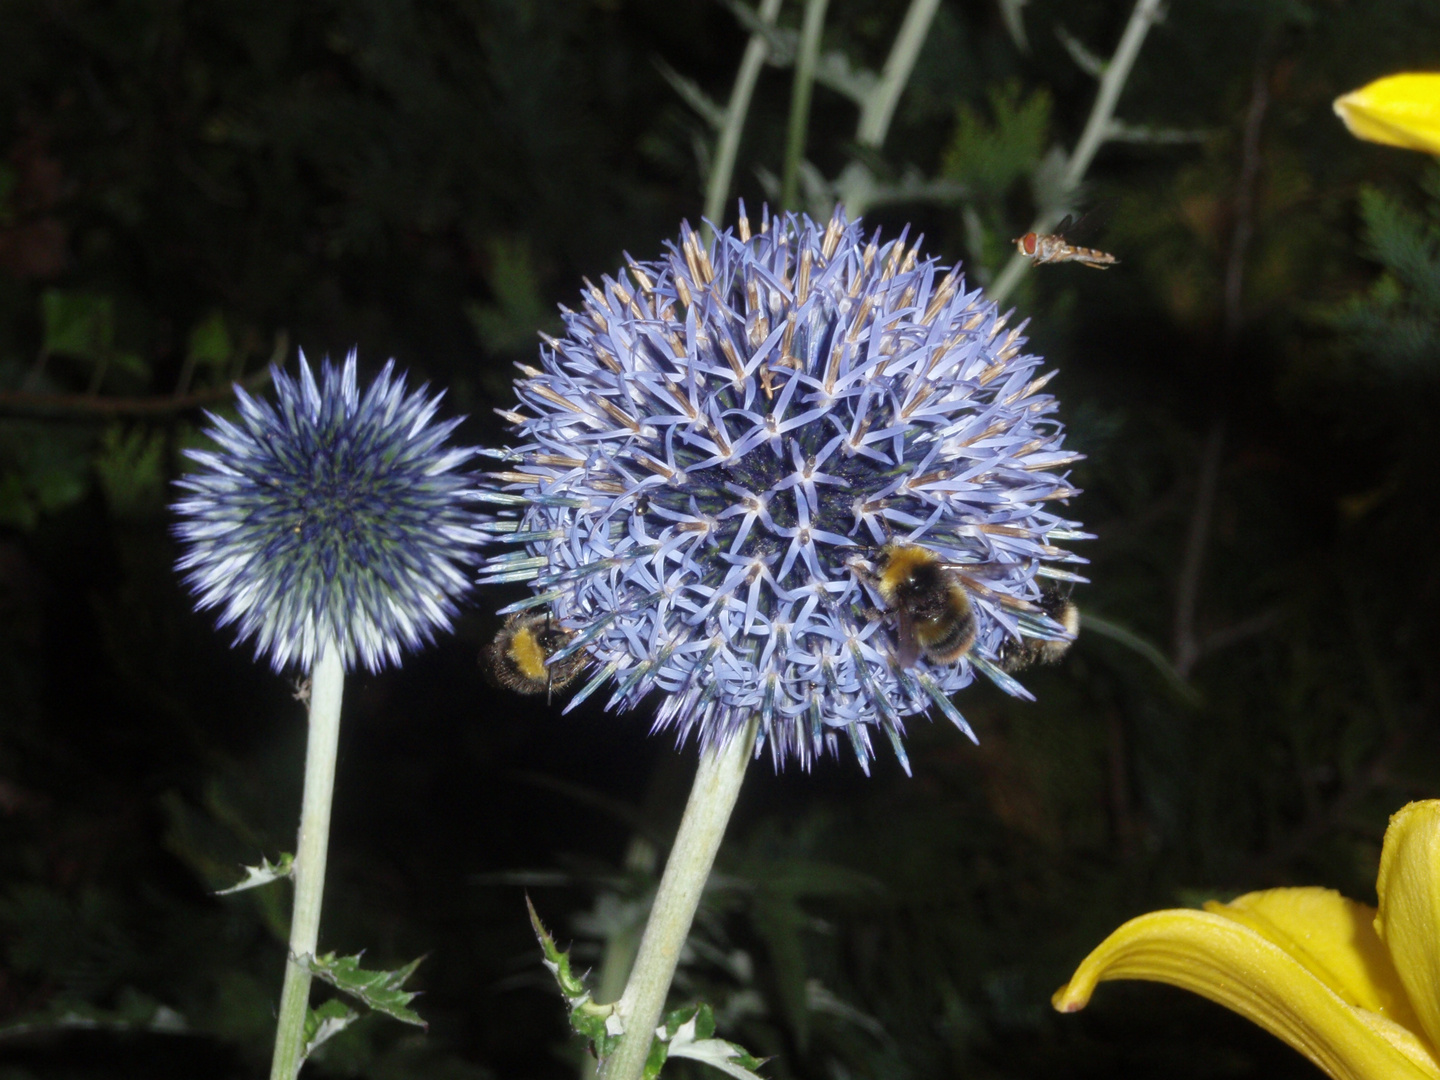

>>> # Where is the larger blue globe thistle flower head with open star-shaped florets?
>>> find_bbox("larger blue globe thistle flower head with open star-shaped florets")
[482,207,1084,770]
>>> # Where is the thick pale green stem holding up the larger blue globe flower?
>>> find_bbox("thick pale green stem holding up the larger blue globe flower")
[600,720,756,1080]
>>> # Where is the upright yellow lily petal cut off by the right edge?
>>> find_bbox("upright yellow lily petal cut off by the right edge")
[1375,799,1440,1044]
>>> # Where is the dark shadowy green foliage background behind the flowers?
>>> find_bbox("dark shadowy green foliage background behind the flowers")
[8,0,1440,1080]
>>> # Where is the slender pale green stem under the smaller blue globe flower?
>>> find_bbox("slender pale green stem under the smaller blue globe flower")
[271,641,346,1080]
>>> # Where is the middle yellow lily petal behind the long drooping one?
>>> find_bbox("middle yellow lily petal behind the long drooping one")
[1205,887,1420,1031]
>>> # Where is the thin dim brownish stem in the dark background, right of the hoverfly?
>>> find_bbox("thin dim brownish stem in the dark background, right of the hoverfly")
[1174,69,1270,678]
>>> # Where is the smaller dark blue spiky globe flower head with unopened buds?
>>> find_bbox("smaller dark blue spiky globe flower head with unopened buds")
[174,353,484,671]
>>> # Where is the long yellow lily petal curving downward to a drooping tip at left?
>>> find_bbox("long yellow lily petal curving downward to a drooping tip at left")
[1053,910,1440,1080]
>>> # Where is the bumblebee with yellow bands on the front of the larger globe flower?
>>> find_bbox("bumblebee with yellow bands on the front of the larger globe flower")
[873,541,976,668]
